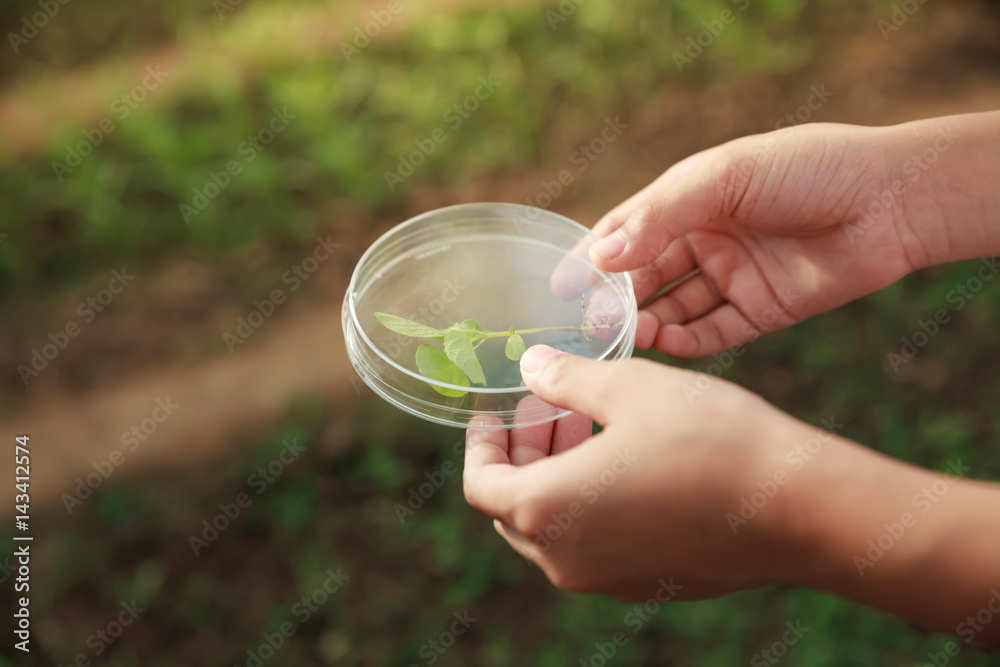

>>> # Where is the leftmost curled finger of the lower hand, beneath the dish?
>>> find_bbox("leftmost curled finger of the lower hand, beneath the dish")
[462,418,518,521]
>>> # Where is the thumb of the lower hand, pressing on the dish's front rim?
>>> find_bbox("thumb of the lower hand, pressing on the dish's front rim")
[521,345,641,425]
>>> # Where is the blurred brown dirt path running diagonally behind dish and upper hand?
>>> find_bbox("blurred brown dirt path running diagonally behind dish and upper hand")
[0,0,1000,513]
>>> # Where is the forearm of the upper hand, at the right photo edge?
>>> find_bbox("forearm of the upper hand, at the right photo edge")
[883,111,1000,268]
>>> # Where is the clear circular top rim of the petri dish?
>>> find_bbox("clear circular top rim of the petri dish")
[347,202,637,394]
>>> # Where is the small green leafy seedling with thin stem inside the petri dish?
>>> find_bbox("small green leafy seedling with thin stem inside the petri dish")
[375,313,620,398]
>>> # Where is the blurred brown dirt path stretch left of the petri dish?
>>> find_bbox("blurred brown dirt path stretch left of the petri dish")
[0,305,357,511]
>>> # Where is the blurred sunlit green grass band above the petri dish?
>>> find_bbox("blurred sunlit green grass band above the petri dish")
[0,0,863,298]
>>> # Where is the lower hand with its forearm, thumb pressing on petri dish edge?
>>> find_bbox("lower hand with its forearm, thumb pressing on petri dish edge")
[463,346,1000,646]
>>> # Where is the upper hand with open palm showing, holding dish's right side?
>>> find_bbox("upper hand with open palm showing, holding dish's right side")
[590,123,921,357]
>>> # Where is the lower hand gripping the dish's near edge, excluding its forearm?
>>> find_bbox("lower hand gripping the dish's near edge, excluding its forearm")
[464,346,835,599]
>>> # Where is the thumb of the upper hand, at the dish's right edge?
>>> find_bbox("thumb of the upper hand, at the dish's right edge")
[590,140,752,272]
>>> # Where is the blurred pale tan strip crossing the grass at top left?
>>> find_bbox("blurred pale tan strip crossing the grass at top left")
[0,0,524,157]
